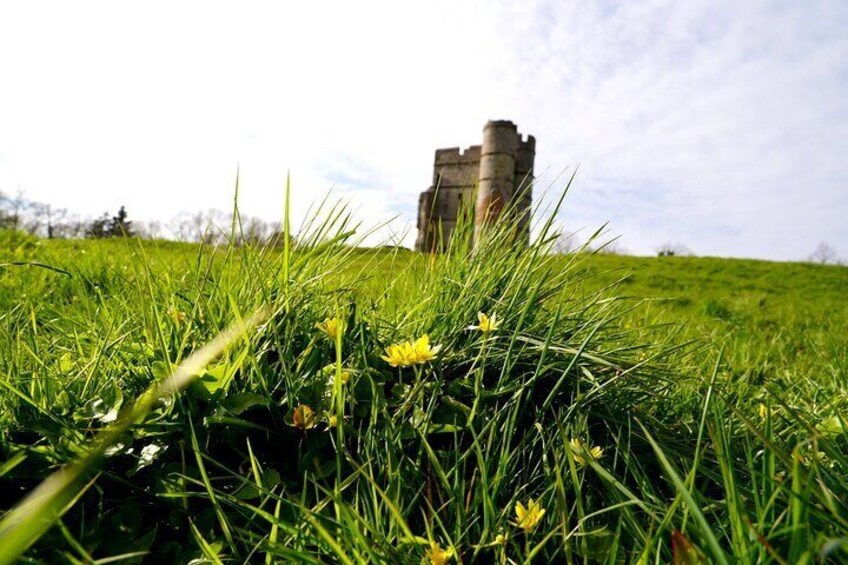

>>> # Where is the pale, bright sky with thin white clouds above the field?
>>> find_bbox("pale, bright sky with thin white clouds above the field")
[0,0,848,260]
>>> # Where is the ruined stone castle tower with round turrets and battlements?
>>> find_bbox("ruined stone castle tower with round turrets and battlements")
[415,121,536,251]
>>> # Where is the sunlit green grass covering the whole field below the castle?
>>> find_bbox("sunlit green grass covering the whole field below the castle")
[0,209,848,563]
